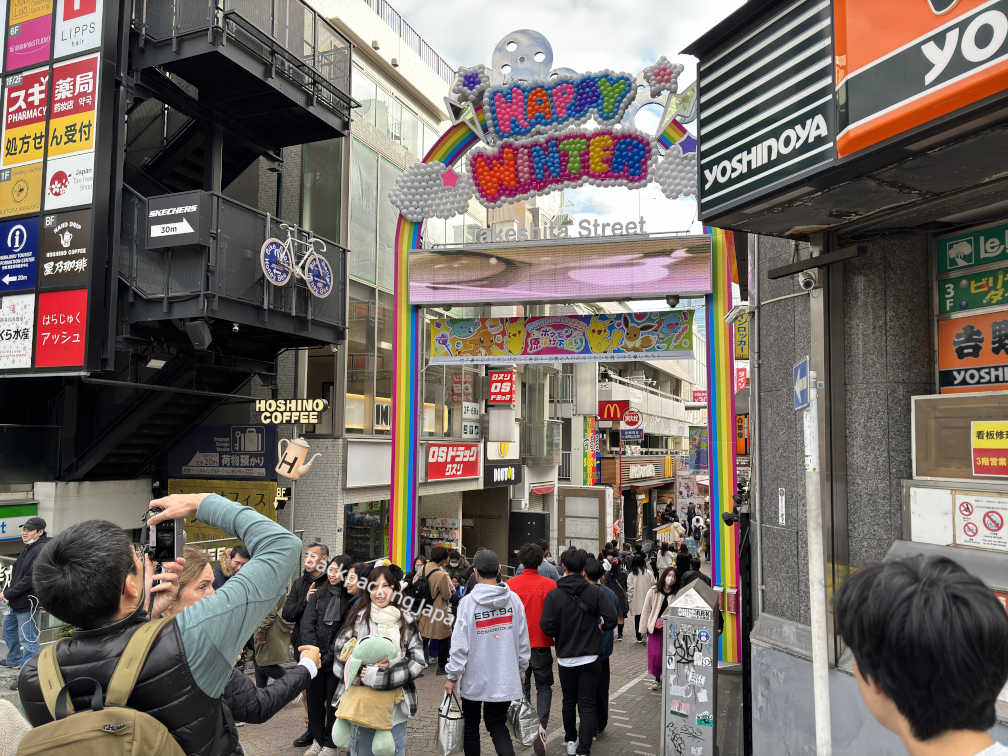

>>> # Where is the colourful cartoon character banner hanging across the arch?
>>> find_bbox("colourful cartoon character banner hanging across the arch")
[430,309,694,365]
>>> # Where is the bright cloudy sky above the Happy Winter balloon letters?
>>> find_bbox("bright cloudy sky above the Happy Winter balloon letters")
[381,0,743,80]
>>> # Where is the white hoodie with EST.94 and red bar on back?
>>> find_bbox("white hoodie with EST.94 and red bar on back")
[445,583,531,702]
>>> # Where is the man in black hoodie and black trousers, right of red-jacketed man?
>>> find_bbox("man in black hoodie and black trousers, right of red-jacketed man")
[539,548,616,756]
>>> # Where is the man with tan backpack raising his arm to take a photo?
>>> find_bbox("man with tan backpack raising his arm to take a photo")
[18,494,301,756]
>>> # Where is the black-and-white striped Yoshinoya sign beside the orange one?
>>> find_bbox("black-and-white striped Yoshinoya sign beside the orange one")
[698,0,835,217]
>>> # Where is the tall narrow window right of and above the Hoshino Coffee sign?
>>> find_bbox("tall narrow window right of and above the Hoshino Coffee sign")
[346,281,375,433]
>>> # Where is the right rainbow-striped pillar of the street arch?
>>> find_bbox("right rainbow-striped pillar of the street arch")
[705,229,742,662]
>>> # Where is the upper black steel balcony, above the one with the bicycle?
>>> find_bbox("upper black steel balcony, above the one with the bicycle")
[132,0,354,148]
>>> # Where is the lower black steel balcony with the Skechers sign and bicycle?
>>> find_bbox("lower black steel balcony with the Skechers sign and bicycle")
[119,186,347,348]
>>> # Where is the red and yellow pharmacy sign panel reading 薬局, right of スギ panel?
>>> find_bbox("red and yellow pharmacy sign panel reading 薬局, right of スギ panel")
[48,54,98,159]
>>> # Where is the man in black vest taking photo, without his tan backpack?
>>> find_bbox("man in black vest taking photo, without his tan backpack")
[18,494,301,756]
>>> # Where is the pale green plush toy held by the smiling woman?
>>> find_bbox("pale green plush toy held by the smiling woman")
[333,635,403,756]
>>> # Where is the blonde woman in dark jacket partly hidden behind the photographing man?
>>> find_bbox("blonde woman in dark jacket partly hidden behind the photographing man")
[161,546,323,756]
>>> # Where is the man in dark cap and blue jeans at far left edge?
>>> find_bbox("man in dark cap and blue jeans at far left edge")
[0,517,49,690]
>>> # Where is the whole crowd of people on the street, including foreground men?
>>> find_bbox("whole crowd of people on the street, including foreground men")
[5,494,1008,756]
